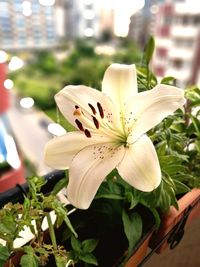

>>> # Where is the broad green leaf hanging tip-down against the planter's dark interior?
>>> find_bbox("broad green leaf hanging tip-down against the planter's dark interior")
[122,210,142,255]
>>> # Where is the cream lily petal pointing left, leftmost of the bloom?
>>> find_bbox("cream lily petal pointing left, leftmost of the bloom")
[44,132,112,170]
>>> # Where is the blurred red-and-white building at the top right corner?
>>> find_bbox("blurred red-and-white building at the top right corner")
[151,1,200,86]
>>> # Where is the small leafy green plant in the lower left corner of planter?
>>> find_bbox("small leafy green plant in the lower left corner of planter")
[0,177,95,267]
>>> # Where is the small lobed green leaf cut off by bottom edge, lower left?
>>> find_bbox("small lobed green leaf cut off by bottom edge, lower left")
[20,246,39,267]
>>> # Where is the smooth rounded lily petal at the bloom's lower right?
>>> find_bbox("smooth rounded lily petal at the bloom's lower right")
[117,135,161,192]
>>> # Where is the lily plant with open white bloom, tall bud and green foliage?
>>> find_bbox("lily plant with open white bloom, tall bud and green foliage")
[42,39,199,266]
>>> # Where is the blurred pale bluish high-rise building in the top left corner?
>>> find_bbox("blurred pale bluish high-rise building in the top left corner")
[0,0,64,50]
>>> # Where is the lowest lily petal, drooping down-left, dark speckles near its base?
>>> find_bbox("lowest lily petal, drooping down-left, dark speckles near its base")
[67,143,124,209]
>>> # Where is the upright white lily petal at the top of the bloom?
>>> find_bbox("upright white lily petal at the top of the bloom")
[102,64,137,113]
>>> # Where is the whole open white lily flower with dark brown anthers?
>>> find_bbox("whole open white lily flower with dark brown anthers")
[45,64,185,209]
